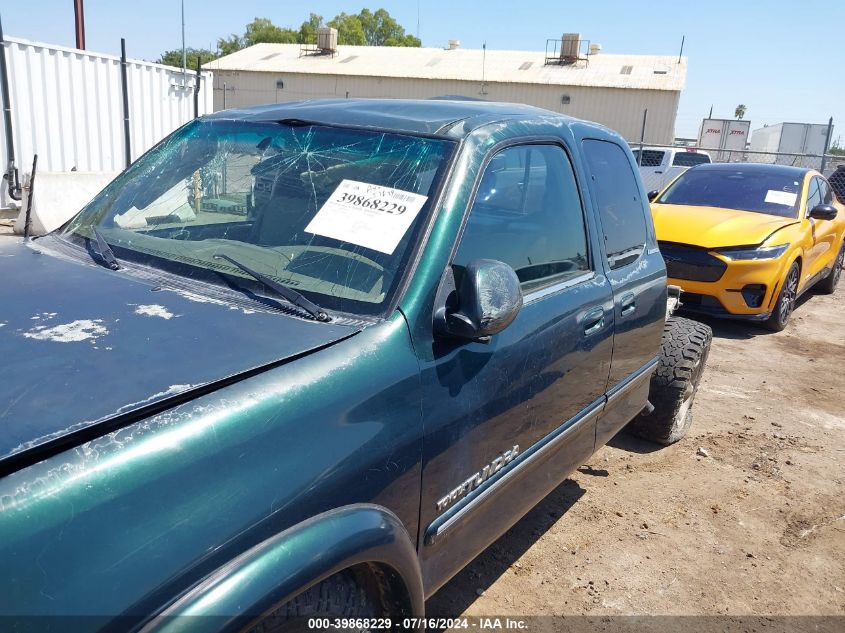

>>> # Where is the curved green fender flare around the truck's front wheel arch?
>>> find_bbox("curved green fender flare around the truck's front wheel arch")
[142,504,424,633]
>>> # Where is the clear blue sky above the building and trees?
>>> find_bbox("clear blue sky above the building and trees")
[0,0,845,141]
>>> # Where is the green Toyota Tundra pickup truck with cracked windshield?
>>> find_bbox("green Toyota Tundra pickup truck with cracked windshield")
[0,100,711,631]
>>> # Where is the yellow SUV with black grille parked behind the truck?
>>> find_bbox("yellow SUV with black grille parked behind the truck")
[649,163,845,331]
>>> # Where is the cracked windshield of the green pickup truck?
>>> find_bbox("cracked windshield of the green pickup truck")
[63,120,452,314]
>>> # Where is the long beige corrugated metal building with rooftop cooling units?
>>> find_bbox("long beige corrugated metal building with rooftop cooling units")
[205,44,687,143]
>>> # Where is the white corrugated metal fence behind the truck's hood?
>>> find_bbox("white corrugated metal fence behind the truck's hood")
[0,36,213,183]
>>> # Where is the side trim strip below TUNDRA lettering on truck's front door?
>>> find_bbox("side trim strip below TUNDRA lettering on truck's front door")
[425,396,605,545]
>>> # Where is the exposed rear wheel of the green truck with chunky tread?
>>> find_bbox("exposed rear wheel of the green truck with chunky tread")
[628,317,713,445]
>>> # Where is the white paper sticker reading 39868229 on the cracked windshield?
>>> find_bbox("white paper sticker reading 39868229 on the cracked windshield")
[305,180,428,255]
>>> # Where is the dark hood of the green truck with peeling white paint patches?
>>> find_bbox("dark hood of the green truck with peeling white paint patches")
[0,238,360,470]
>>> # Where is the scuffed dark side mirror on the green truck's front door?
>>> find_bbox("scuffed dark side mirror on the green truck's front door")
[436,259,522,342]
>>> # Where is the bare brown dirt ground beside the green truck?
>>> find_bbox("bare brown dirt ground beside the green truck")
[426,283,845,617]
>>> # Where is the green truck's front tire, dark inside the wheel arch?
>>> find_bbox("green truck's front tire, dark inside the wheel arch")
[246,570,379,633]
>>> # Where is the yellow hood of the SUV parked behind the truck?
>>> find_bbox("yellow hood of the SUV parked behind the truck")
[651,204,798,248]
